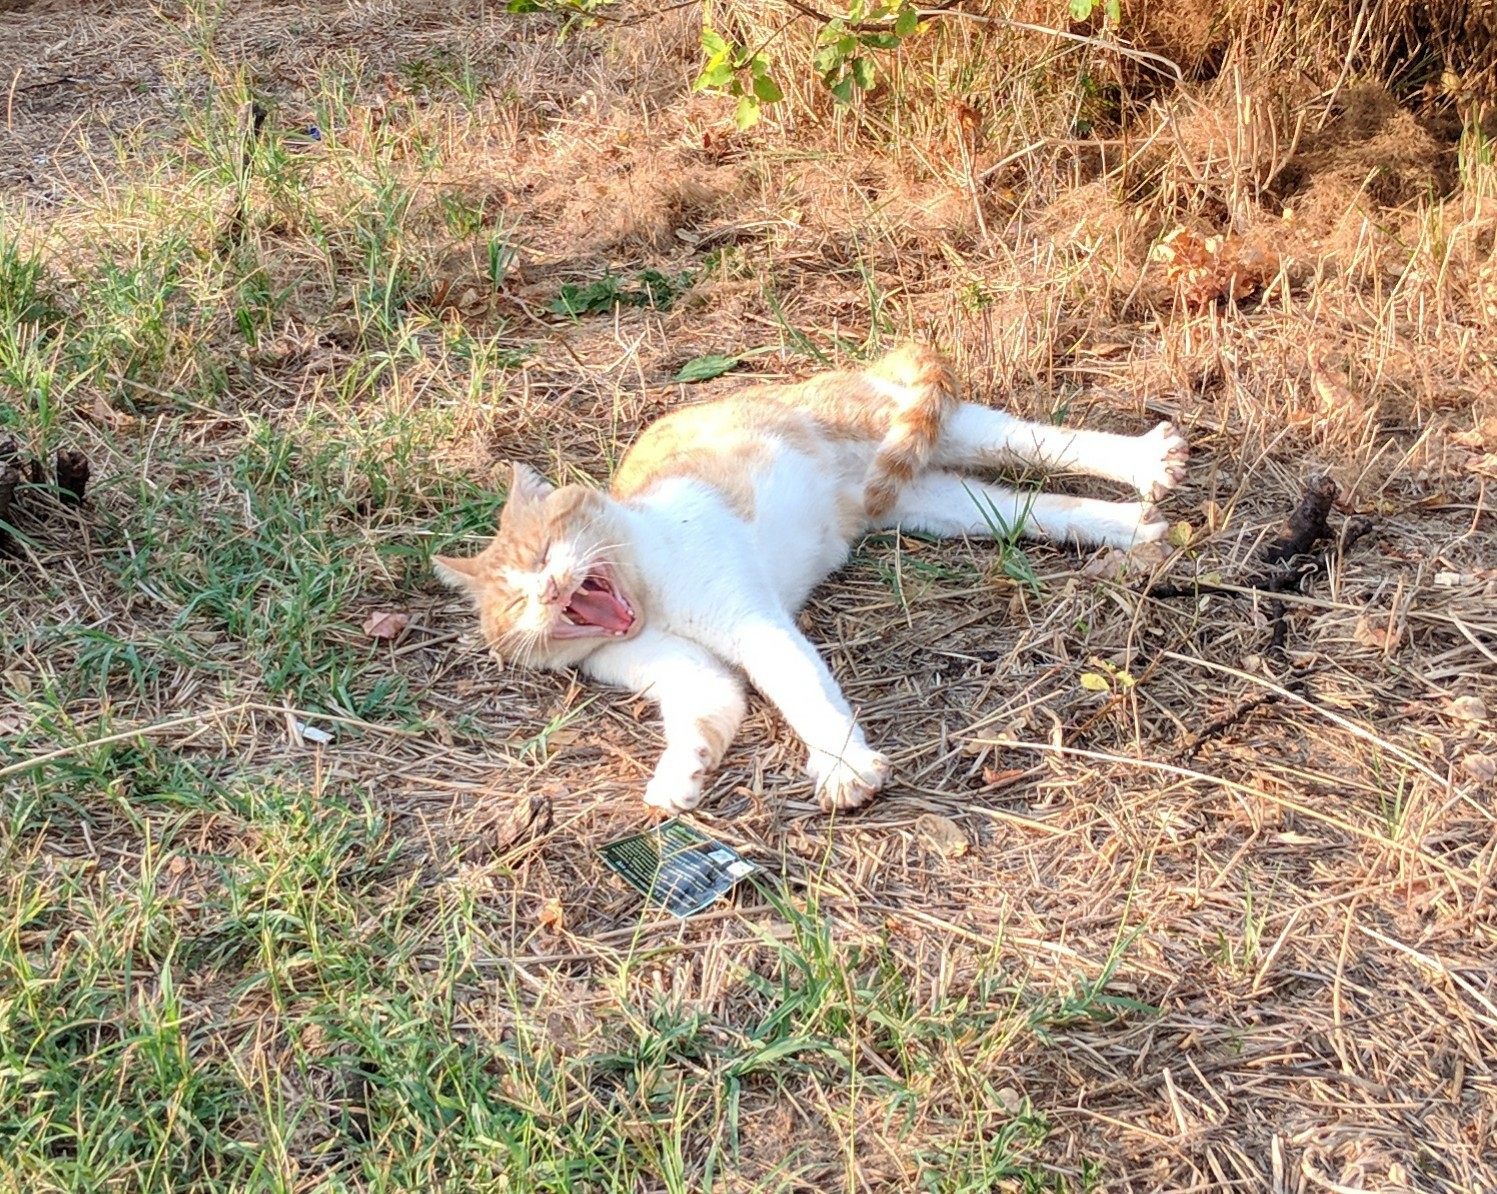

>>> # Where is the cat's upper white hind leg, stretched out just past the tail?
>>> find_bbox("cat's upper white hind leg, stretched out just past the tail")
[931,402,1190,500]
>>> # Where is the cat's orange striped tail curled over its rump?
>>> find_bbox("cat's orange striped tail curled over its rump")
[862,344,958,518]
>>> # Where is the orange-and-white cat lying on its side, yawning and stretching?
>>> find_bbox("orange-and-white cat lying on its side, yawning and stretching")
[433,344,1187,812]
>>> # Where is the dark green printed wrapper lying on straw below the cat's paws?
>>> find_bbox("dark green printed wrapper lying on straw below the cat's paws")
[599,818,763,917]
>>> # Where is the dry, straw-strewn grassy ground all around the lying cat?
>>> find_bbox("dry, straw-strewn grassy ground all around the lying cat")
[0,3,1497,1191]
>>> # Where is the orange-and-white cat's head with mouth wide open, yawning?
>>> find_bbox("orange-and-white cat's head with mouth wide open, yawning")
[431,464,639,667]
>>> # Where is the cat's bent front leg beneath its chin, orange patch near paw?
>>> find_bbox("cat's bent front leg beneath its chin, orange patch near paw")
[582,625,746,812]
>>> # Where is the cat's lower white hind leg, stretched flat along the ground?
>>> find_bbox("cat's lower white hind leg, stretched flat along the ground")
[882,471,1169,548]
